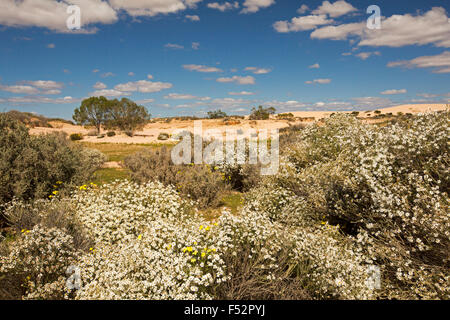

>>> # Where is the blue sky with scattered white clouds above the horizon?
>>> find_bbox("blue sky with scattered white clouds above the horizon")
[0,0,450,119]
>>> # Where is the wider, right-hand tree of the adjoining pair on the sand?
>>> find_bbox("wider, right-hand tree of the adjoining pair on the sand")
[106,98,151,134]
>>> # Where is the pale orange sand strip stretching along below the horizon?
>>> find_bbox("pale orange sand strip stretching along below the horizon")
[30,104,446,144]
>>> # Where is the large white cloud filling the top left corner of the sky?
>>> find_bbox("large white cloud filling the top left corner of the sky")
[0,0,117,33]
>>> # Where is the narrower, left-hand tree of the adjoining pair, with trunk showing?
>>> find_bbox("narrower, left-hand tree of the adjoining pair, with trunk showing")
[72,97,109,134]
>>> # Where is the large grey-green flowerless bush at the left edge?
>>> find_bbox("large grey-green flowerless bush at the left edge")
[0,115,104,203]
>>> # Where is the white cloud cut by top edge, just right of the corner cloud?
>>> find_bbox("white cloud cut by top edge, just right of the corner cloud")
[110,0,202,16]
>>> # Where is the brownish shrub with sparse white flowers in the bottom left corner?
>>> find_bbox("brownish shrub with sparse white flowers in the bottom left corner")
[0,225,79,300]
